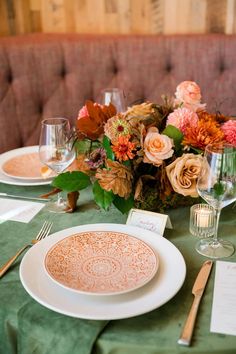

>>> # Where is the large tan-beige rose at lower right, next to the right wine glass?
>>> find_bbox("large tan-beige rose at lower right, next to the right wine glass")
[166,154,203,197]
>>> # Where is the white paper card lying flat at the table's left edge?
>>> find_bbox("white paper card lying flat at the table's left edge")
[0,198,45,223]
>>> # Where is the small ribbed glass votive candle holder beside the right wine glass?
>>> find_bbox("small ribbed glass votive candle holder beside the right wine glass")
[189,204,215,253]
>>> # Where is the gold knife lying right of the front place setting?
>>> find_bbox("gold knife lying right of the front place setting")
[178,261,213,346]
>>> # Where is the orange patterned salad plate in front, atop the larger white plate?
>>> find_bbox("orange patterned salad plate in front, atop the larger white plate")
[44,230,159,295]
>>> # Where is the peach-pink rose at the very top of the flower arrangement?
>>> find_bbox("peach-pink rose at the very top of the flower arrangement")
[175,81,206,112]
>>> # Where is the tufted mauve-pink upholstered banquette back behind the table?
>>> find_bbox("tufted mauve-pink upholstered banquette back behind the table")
[0,34,236,152]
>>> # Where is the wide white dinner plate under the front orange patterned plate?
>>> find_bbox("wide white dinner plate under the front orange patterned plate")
[20,224,186,320]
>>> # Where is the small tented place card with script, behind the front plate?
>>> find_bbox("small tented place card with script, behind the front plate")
[126,209,172,236]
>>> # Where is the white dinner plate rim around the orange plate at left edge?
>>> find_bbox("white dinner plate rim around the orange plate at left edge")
[0,145,52,186]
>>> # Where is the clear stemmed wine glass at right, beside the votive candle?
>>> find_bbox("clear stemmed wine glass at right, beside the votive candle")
[197,143,236,258]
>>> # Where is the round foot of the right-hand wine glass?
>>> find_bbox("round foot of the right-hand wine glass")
[195,239,234,259]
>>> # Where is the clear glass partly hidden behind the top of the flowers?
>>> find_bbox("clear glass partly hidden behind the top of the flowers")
[102,88,126,112]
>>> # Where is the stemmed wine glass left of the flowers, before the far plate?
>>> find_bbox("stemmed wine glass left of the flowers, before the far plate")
[39,118,75,213]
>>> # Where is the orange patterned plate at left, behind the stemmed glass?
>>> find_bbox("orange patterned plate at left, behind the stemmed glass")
[2,152,54,180]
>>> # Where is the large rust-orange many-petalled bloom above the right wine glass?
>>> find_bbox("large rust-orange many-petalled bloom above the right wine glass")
[183,119,224,150]
